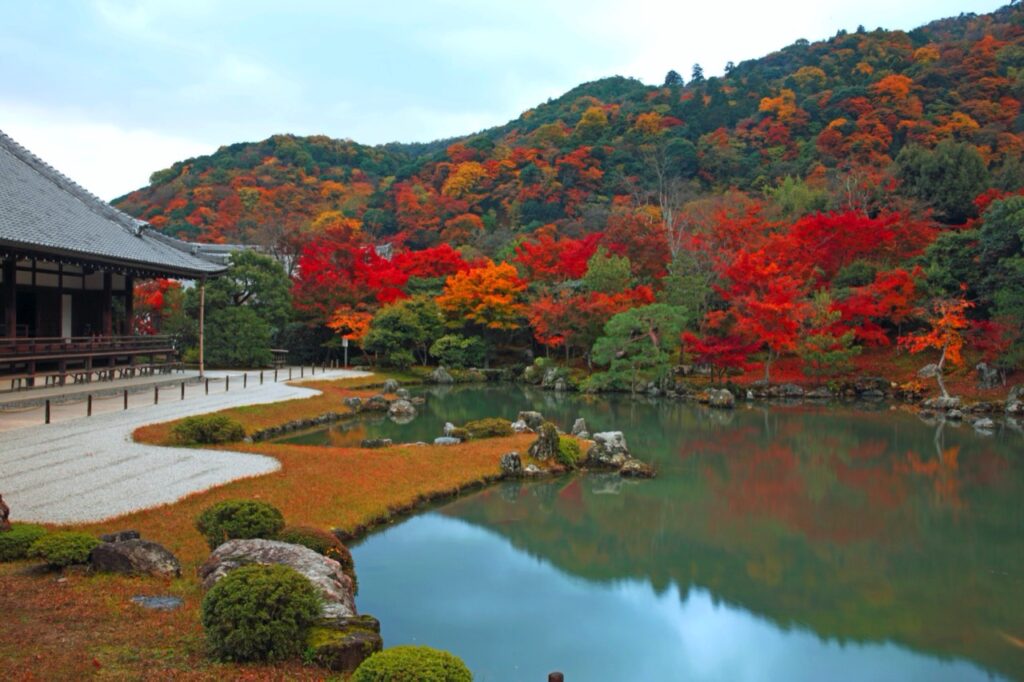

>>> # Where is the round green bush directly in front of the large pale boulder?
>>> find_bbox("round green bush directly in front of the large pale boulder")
[202,564,321,662]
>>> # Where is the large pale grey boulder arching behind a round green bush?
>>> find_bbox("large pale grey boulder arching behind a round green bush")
[199,540,356,621]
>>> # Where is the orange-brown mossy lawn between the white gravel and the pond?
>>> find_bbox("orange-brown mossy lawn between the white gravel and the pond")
[0,377,531,680]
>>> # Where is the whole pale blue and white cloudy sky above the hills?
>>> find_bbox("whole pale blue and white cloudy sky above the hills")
[0,0,1006,200]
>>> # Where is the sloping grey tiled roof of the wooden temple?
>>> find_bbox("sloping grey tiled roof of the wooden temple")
[0,131,226,278]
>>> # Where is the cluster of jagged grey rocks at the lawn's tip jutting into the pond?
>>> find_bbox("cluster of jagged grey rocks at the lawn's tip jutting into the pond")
[501,412,654,478]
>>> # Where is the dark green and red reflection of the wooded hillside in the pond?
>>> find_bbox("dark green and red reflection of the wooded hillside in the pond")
[444,410,1024,675]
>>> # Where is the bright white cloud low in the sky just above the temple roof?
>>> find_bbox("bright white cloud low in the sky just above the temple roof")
[0,101,214,201]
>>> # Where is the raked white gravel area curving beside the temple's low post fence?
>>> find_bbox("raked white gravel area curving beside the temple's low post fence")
[0,370,368,523]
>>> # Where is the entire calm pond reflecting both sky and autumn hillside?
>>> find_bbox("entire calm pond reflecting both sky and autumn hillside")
[284,386,1024,682]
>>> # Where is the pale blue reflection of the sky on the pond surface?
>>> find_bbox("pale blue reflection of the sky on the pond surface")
[352,514,993,682]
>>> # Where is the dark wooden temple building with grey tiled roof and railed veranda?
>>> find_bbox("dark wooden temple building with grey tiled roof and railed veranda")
[0,131,229,385]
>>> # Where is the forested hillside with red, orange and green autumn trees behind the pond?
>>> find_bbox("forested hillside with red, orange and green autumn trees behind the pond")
[117,5,1024,383]
